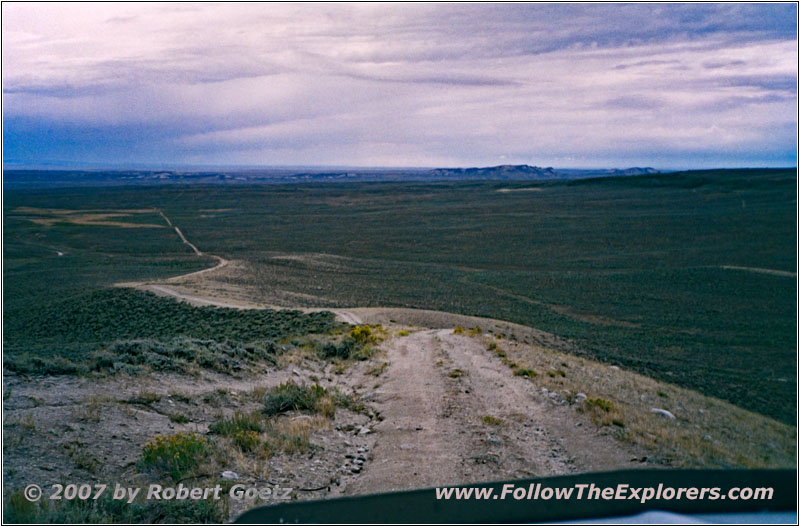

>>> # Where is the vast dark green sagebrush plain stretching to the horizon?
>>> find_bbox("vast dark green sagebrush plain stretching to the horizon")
[3,170,797,422]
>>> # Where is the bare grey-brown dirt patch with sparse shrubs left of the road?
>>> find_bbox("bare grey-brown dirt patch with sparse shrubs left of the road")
[3,359,382,519]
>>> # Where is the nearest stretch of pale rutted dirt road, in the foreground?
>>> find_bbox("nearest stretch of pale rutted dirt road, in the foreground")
[345,329,642,494]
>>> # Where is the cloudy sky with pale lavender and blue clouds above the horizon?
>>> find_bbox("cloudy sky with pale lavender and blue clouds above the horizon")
[2,2,798,169]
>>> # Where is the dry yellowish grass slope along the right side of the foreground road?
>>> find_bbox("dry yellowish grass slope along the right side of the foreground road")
[487,340,797,468]
